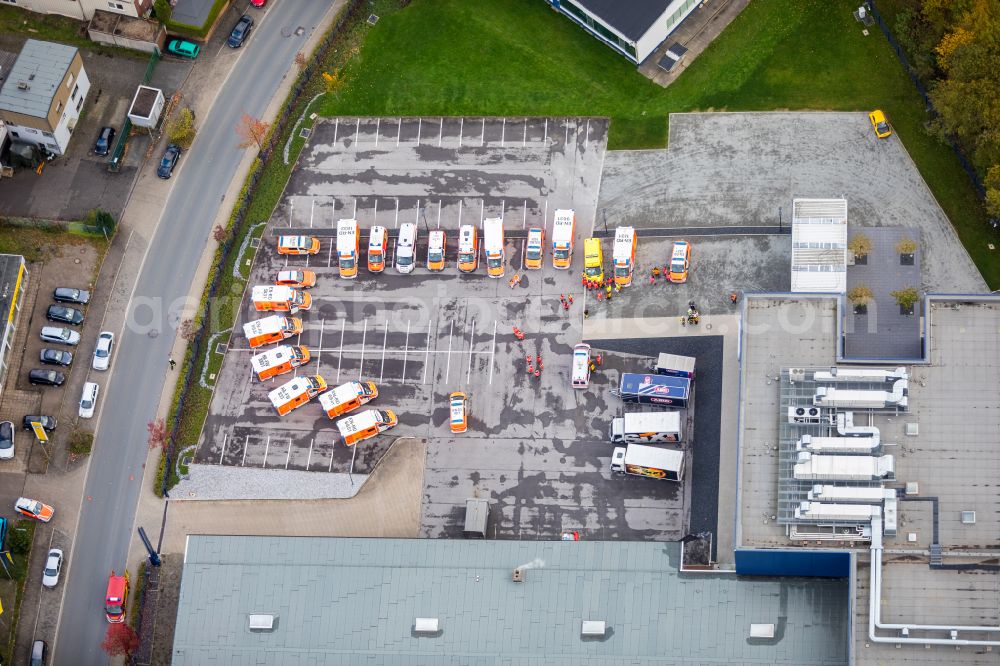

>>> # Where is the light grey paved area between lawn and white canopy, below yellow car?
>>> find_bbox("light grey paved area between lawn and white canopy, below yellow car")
[598,112,986,293]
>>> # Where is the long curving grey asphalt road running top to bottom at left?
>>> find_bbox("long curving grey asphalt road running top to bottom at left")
[54,2,329,664]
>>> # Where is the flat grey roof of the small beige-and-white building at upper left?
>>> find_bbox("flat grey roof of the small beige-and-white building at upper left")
[0,39,77,118]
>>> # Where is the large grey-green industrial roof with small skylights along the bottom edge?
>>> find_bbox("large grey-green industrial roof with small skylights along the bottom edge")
[172,536,849,666]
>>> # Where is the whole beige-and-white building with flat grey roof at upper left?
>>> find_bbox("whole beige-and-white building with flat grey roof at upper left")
[0,39,90,155]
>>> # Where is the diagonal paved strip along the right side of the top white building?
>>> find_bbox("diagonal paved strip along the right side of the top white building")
[639,0,750,88]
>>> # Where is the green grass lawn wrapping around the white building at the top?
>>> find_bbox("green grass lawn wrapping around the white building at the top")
[318,0,1000,289]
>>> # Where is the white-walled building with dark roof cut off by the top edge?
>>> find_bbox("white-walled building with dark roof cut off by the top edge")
[545,0,702,64]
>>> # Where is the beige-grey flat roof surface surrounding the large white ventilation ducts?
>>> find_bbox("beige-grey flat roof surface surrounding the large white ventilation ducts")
[737,294,1000,665]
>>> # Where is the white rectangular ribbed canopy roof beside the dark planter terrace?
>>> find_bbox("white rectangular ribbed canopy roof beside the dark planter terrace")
[792,199,847,294]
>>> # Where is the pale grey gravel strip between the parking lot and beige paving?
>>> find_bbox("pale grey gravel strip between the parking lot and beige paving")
[170,464,368,500]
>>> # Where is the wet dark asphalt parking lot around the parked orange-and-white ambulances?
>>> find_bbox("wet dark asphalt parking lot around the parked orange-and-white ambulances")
[196,118,687,539]
